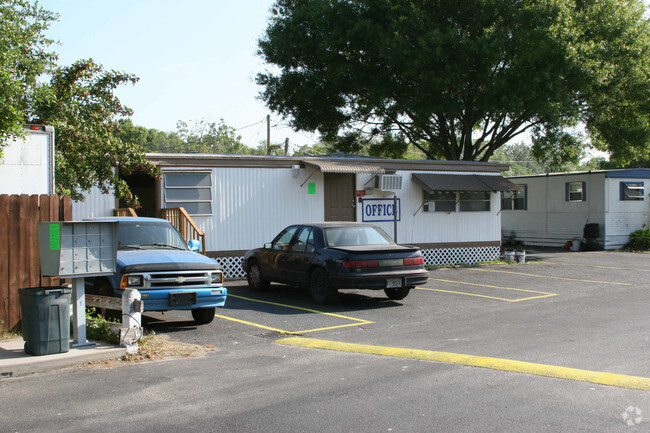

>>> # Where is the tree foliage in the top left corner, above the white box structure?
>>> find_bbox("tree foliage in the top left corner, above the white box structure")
[0,0,57,140]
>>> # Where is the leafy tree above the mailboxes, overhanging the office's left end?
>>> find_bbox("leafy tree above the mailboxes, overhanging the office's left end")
[29,59,159,206]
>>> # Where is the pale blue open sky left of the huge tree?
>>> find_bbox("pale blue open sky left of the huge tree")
[39,0,317,150]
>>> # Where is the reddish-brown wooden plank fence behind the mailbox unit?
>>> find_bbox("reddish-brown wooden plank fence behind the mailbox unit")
[0,194,72,329]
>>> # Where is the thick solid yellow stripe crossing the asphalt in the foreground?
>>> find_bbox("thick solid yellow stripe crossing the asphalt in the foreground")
[275,337,650,391]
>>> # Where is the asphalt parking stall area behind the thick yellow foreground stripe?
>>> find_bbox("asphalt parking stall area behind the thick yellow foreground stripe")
[197,248,650,377]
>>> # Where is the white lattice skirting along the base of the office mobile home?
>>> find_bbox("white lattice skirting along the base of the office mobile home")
[215,246,501,280]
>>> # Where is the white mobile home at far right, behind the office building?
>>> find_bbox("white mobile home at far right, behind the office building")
[501,168,650,249]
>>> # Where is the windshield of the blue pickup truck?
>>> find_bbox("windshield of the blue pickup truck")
[118,221,187,250]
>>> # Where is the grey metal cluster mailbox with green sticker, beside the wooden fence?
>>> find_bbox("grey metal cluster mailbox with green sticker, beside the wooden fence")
[38,221,119,278]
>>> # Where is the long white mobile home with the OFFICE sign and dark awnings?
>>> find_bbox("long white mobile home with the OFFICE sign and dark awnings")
[73,154,516,277]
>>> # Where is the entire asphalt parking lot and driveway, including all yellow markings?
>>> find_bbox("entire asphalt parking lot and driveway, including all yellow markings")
[0,251,650,432]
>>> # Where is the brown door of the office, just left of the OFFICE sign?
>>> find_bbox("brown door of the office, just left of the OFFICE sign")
[325,173,356,221]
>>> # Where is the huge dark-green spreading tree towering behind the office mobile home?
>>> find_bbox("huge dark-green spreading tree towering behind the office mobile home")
[257,0,650,162]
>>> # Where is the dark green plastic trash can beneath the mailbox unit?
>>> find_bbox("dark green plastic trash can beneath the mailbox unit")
[18,287,72,355]
